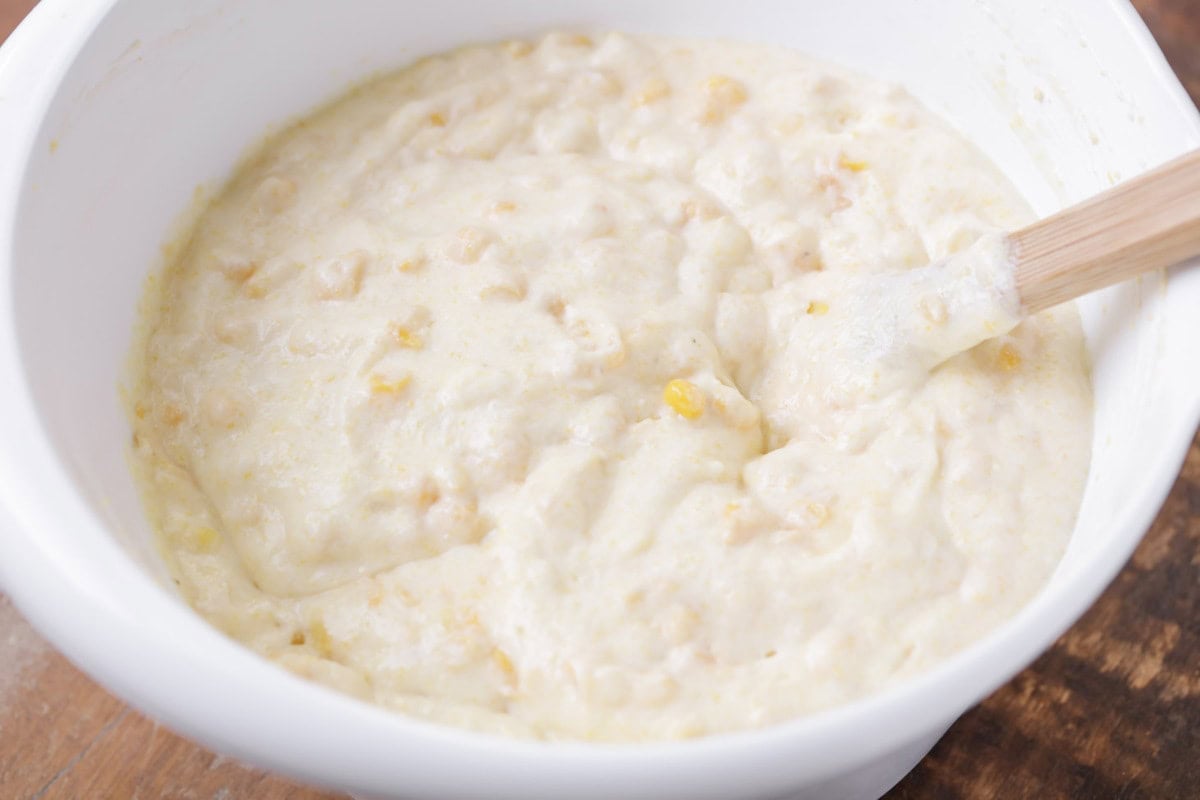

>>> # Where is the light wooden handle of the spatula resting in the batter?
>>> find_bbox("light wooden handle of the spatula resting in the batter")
[1009,150,1200,314]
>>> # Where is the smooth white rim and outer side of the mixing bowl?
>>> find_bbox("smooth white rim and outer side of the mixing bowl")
[0,0,1200,796]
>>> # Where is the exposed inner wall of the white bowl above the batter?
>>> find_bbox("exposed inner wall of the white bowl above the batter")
[7,0,1200,796]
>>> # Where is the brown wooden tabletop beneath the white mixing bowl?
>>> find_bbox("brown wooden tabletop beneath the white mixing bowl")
[0,0,1200,800]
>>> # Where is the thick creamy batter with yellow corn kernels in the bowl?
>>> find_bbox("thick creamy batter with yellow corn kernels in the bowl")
[133,34,1091,740]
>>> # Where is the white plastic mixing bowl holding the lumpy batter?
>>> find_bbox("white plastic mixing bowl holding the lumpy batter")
[0,0,1200,800]
